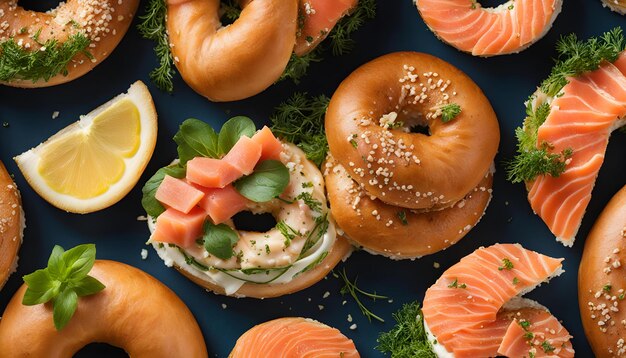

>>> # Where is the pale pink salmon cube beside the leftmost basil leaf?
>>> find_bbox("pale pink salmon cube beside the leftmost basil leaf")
[155,175,204,214]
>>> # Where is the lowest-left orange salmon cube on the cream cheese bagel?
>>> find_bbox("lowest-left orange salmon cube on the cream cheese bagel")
[150,207,206,248]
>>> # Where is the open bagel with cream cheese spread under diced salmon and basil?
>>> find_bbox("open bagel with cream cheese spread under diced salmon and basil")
[148,144,352,298]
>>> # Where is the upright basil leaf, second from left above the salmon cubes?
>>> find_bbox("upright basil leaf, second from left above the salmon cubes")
[174,118,219,166]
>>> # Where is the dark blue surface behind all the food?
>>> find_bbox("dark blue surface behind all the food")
[0,0,626,357]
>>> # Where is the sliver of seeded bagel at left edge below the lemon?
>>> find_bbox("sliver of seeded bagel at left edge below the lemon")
[0,161,24,289]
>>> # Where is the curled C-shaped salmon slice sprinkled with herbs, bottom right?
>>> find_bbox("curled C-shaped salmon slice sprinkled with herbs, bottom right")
[422,244,571,358]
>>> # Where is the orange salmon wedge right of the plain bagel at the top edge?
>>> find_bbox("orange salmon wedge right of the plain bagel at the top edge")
[294,0,359,56]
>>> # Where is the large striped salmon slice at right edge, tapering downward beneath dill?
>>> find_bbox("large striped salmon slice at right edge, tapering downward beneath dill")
[527,53,626,246]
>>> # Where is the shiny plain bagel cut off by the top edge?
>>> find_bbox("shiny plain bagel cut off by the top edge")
[167,0,298,102]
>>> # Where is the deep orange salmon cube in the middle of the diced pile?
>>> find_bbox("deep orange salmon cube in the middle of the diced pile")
[198,185,248,225]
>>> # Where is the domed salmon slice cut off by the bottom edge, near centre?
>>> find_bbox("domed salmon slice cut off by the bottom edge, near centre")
[229,317,360,358]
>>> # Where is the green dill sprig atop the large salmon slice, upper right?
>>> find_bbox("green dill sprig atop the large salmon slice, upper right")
[541,27,626,96]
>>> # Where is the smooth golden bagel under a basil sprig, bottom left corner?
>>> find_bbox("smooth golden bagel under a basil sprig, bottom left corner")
[0,260,208,358]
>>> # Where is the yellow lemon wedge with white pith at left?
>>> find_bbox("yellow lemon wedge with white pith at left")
[14,81,157,214]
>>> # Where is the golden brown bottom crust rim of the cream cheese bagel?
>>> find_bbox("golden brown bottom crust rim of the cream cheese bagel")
[174,236,353,298]
